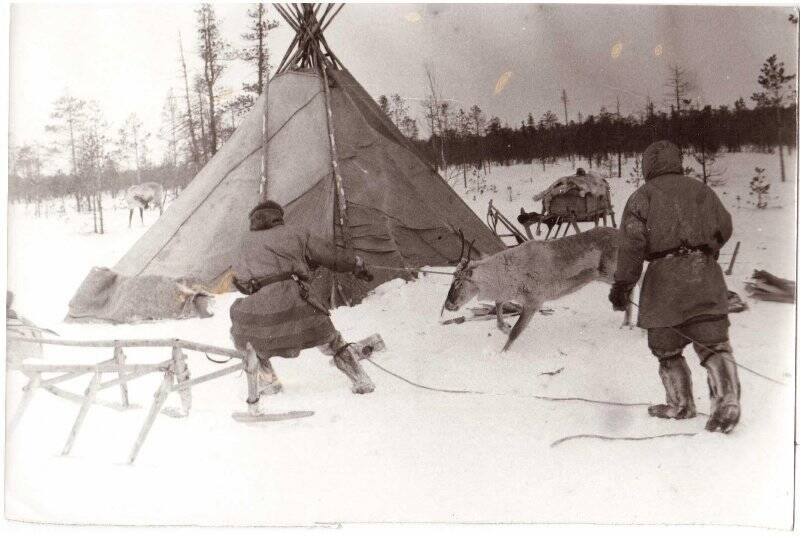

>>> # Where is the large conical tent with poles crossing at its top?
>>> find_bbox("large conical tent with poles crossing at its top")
[72,5,504,318]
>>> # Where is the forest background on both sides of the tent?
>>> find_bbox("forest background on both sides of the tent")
[9,4,797,233]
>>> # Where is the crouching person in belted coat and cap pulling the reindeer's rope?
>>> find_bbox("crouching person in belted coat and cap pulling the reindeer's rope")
[231,201,375,406]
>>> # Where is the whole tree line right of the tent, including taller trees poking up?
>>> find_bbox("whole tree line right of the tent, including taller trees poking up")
[410,55,797,183]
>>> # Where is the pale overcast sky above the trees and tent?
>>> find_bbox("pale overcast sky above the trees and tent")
[10,4,798,165]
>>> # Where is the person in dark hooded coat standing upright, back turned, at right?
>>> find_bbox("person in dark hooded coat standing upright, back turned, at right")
[609,141,740,433]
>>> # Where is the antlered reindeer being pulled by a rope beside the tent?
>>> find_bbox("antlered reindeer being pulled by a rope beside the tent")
[444,227,619,351]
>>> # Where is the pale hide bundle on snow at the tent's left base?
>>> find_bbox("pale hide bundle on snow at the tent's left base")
[65,267,213,323]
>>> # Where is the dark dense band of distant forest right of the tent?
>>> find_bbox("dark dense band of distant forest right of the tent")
[416,99,797,177]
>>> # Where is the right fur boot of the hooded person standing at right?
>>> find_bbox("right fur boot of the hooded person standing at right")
[701,343,741,433]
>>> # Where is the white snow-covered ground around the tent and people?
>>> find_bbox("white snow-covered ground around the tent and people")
[6,154,796,528]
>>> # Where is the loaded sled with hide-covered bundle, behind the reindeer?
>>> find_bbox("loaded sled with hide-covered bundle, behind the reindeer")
[517,168,617,239]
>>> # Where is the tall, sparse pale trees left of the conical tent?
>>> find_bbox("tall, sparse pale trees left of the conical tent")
[9,3,278,233]
